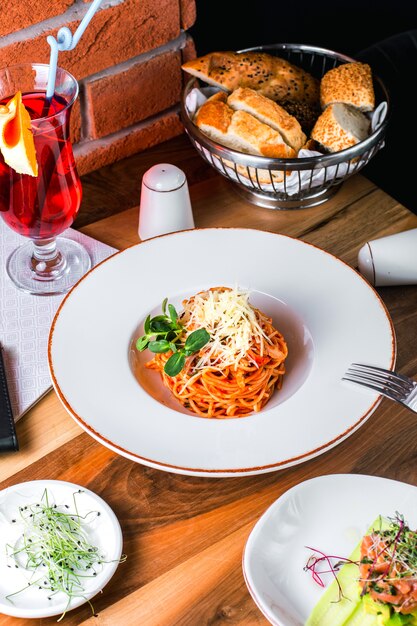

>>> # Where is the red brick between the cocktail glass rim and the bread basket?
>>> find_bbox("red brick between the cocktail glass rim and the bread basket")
[85,51,182,138]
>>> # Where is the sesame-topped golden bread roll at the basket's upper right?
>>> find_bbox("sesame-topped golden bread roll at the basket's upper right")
[320,62,375,111]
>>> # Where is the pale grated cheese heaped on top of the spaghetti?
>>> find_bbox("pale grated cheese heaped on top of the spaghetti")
[181,287,268,369]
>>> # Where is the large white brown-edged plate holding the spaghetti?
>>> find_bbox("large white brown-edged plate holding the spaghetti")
[48,228,395,476]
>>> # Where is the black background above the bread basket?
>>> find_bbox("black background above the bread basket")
[189,0,417,58]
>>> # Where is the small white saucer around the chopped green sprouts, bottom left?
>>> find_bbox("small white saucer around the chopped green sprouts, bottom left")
[0,480,122,618]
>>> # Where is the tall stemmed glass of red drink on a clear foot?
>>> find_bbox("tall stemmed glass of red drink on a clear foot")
[0,63,91,295]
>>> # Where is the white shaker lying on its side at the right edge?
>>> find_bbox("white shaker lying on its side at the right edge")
[358,228,417,287]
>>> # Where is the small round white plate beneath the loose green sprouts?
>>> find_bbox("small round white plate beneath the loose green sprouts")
[0,480,123,618]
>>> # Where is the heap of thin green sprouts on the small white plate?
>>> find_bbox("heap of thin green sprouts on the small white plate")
[6,489,126,622]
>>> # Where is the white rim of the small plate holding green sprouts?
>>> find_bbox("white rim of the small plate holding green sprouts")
[0,479,123,619]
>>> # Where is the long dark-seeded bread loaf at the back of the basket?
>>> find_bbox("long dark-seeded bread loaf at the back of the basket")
[182,51,320,103]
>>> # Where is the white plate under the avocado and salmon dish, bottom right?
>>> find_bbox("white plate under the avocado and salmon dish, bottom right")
[243,474,417,626]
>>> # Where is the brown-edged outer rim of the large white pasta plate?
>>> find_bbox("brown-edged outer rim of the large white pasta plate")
[48,227,397,477]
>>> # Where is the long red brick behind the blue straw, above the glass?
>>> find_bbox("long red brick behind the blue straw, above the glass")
[0,0,180,80]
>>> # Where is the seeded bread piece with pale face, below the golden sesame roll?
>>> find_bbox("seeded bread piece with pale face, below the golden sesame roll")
[311,103,370,152]
